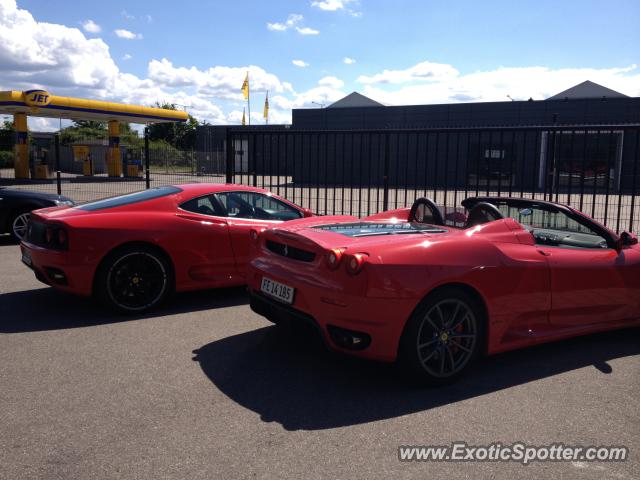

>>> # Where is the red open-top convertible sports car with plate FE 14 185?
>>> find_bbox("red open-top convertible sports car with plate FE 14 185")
[247,197,640,384]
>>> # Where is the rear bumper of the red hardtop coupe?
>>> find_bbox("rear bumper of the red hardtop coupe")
[20,242,95,296]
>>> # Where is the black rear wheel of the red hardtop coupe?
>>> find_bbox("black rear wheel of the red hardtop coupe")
[94,245,174,314]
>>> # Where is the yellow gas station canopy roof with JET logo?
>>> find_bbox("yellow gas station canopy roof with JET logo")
[0,90,188,124]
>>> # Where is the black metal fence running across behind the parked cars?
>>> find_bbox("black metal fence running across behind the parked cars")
[0,125,640,231]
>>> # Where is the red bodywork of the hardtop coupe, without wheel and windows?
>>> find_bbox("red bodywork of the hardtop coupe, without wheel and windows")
[21,184,309,296]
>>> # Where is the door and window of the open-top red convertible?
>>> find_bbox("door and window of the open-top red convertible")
[536,212,640,327]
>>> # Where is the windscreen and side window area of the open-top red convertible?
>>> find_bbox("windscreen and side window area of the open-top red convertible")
[496,203,608,248]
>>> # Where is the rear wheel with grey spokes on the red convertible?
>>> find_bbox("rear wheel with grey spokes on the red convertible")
[398,287,487,385]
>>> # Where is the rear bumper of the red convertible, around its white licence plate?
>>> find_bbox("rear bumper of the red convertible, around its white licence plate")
[247,264,417,362]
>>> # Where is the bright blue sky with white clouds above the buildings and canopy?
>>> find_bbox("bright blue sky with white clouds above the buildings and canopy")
[0,0,640,130]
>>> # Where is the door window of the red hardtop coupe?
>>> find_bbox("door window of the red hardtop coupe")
[216,192,303,220]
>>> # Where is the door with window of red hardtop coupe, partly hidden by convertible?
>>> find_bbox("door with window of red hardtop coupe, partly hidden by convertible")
[215,191,303,275]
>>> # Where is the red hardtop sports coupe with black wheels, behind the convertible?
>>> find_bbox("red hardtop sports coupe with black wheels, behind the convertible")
[21,183,312,312]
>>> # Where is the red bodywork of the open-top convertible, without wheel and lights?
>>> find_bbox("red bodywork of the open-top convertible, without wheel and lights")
[247,204,640,361]
